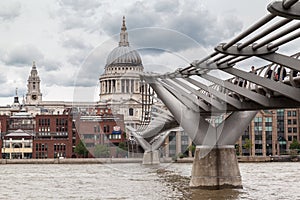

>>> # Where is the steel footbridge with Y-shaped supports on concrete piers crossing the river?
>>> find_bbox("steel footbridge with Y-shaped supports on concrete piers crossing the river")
[128,0,300,189]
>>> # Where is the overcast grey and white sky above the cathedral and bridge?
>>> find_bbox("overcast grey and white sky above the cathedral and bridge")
[0,0,278,105]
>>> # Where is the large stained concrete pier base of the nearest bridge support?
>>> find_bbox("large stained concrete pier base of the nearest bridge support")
[190,145,243,189]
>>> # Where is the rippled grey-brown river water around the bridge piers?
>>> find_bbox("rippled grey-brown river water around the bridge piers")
[0,162,300,200]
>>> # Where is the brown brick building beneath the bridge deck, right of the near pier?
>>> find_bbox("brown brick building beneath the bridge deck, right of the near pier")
[237,109,300,156]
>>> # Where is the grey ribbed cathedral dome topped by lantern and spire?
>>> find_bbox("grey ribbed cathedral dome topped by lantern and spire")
[106,17,142,67]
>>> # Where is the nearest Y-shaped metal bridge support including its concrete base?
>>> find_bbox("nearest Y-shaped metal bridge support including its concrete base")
[144,77,257,189]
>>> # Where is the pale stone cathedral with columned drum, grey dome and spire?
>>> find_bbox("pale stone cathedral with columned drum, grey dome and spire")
[99,17,144,128]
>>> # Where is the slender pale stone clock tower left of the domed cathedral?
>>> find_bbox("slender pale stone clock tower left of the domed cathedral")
[26,61,42,104]
